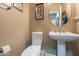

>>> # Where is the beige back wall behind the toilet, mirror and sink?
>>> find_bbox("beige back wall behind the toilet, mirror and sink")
[30,4,76,55]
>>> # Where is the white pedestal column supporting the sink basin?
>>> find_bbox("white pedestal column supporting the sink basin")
[57,40,66,56]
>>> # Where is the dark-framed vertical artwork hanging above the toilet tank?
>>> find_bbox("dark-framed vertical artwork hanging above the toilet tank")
[35,3,44,20]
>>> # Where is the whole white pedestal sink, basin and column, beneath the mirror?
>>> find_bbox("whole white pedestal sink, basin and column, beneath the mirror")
[49,32,79,56]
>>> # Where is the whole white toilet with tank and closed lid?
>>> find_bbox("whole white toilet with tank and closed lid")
[21,32,43,56]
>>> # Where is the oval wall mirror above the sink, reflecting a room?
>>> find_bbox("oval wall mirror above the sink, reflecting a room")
[48,3,71,27]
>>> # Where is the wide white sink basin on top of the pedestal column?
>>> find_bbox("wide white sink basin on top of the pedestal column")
[49,32,79,41]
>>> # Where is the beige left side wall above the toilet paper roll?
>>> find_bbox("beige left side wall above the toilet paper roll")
[0,4,29,55]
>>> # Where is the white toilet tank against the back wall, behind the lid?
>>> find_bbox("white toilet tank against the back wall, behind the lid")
[32,32,43,45]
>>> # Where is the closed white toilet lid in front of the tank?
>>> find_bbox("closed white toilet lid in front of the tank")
[22,45,41,56]
